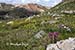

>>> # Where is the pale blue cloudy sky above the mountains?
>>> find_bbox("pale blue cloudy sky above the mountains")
[0,0,62,7]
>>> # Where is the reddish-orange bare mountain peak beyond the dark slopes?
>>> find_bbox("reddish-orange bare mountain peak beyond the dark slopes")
[15,3,46,12]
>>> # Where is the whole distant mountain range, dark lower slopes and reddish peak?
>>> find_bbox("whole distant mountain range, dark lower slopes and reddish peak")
[0,3,46,19]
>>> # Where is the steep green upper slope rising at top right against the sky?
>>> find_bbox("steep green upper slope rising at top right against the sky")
[48,0,75,15]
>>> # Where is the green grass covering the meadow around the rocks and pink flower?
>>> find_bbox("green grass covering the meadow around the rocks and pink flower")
[0,15,75,50]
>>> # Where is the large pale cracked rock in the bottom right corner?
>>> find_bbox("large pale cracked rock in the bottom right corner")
[46,38,75,50]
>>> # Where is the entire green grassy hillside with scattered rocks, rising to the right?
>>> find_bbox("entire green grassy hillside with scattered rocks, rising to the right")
[0,1,75,50]
